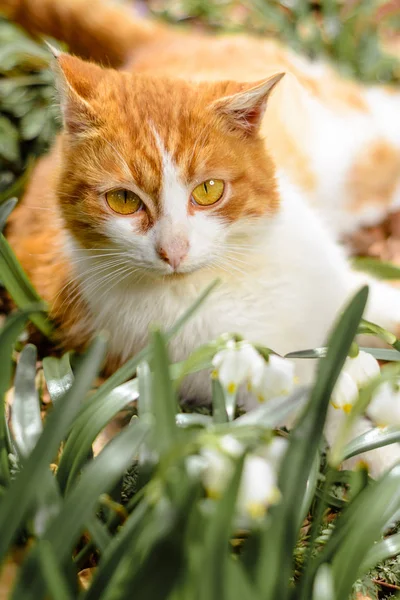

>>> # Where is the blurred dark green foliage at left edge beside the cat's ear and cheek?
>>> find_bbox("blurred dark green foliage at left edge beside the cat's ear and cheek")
[0,18,57,202]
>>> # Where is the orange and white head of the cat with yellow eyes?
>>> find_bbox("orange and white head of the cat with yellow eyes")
[57,54,282,276]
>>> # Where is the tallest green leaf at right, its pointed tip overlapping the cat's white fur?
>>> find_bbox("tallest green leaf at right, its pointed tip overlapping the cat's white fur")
[257,288,368,600]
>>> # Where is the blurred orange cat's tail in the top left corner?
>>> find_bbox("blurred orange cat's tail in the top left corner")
[0,0,165,67]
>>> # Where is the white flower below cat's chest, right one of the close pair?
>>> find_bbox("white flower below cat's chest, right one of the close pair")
[251,354,294,402]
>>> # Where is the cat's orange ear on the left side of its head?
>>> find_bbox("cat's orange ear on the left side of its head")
[51,48,105,134]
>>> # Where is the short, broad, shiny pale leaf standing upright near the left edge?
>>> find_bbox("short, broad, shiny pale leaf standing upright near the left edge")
[11,344,43,457]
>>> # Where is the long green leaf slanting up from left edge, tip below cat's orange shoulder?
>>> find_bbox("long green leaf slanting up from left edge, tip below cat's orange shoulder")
[0,337,106,564]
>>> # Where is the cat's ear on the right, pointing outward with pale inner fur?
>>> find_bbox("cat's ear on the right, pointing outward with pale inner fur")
[212,73,285,135]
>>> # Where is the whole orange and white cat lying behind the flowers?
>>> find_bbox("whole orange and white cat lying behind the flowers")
[0,0,400,472]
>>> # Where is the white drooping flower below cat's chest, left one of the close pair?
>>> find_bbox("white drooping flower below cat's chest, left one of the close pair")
[212,340,264,394]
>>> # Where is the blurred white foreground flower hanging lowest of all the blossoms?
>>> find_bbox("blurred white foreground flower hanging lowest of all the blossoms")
[237,454,281,520]
